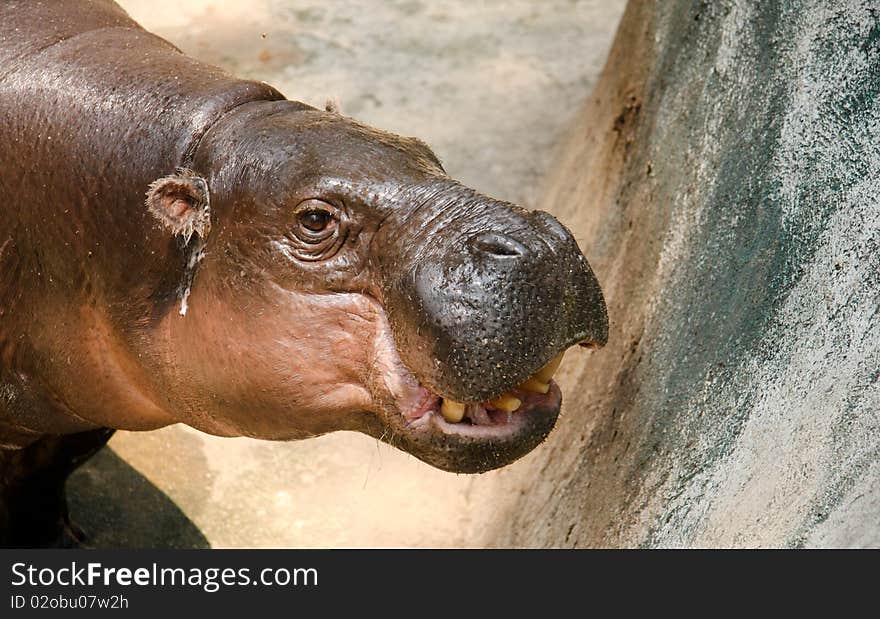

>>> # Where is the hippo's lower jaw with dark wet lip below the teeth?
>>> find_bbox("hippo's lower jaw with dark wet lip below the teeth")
[367,383,562,473]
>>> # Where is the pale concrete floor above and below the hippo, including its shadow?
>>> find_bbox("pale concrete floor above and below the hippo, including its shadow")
[70,0,624,547]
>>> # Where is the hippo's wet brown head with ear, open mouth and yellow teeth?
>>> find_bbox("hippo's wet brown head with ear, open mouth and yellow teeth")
[148,101,608,472]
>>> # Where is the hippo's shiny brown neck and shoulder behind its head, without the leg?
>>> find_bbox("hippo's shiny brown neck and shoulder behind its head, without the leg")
[0,2,282,446]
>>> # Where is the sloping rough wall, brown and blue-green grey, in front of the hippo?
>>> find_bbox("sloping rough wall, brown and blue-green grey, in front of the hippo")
[477,0,880,547]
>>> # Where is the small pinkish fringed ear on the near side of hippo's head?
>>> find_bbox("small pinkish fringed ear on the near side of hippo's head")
[147,169,211,244]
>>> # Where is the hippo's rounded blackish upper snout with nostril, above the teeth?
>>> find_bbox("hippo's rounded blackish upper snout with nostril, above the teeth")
[385,196,608,402]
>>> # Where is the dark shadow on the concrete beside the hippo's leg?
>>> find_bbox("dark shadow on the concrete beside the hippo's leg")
[67,448,210,548]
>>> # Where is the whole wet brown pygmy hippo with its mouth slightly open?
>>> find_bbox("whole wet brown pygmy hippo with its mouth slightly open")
[0,0,608,546]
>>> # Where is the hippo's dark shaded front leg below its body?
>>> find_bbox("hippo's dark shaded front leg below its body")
[0,428,114,548]
